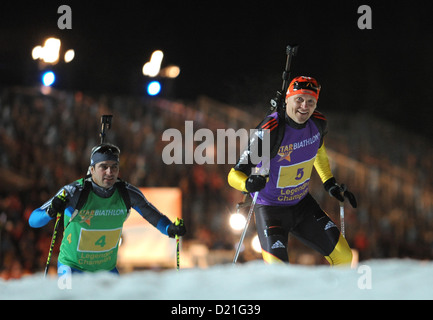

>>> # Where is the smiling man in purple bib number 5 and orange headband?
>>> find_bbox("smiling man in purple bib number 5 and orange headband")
[228,76,357,265]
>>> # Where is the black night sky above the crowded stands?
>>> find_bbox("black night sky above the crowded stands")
[0,0,433,136]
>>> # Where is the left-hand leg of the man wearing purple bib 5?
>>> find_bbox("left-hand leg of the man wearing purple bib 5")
[255,205,289,264]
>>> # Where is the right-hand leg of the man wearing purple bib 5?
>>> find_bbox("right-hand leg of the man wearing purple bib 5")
[292,194,352,265]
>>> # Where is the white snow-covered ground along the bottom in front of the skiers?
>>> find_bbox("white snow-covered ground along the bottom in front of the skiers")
[0,259,433,300]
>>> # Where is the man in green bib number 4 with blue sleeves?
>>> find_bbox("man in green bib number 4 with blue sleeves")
[29,144,186,274]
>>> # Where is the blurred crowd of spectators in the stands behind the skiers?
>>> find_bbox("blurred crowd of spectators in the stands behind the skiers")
[0,88,433,279]
